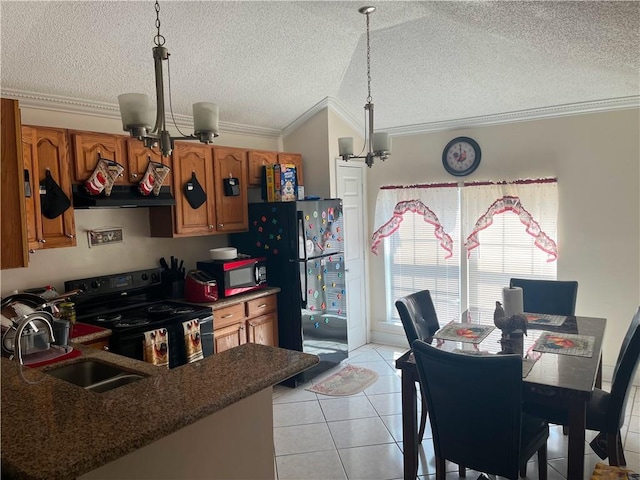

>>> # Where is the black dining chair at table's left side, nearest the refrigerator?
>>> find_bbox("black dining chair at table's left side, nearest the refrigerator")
[396,290,440,443]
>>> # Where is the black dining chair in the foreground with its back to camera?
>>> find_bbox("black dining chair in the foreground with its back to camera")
[412,340,549,480]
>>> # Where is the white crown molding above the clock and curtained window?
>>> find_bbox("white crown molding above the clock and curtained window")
[384,95,640,136]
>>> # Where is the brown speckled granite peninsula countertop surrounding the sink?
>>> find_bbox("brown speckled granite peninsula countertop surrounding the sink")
[0,343,318,479]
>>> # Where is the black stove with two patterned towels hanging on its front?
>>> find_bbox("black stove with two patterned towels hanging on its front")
[64,268,213,368]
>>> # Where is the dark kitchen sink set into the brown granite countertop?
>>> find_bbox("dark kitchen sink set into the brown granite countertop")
[45,360,147,393]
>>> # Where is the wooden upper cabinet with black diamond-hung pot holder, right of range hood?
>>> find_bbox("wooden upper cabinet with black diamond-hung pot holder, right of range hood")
[149,142,216,237]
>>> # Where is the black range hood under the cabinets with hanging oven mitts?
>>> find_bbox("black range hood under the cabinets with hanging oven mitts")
[72,184,176,208]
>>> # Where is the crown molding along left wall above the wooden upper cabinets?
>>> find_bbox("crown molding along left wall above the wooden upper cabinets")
[0,88,282,138]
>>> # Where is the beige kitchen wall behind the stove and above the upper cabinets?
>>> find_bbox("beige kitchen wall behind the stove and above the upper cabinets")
[0,108,281,297]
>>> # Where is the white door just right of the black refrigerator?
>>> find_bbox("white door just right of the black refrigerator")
[336,161,368,351]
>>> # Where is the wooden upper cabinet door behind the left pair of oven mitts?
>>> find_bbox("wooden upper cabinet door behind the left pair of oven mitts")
[69,130,127,185]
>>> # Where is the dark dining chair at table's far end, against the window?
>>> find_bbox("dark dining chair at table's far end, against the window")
[509,278,578,315]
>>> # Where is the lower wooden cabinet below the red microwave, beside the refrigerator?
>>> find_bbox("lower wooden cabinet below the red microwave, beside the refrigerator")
[213,293,278,353]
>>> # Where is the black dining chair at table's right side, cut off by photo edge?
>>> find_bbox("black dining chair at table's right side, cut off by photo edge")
[524,308,640,466]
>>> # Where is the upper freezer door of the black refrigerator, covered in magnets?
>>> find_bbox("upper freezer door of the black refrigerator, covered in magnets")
[296,198,344,260]
